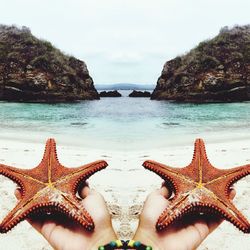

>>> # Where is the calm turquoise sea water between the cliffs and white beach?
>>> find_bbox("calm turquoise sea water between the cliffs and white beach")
[0,91,250,150]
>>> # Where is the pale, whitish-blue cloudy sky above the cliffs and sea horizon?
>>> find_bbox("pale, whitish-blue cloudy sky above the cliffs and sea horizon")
[0,0,250,84]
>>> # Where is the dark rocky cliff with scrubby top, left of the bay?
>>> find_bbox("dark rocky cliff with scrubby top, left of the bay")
[0,25,99,102]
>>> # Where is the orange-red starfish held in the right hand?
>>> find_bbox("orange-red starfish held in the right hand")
[143,139,250,233]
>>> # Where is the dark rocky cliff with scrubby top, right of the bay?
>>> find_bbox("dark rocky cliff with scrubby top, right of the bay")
[151,25,250,103]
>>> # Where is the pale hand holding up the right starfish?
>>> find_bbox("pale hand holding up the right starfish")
[134,186,235,250]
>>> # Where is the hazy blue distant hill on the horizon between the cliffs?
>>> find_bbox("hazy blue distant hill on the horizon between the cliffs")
[95,83,155,90]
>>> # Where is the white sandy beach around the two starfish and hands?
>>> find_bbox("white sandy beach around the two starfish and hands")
[0,138,250,250]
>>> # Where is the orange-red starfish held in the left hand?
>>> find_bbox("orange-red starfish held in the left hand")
[0,139,108,233]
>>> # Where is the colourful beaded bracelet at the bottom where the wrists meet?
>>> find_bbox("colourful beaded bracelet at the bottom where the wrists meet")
[98,240,153,250]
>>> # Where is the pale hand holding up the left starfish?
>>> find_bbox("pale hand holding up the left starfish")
[16,186,117,250]
